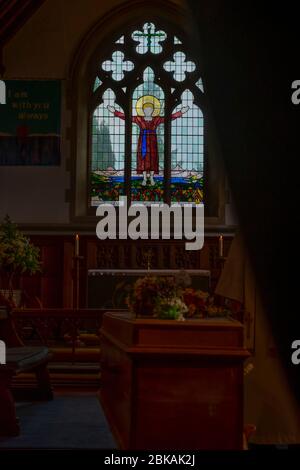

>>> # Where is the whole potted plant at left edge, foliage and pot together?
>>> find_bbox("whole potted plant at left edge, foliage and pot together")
[0,215,40,305]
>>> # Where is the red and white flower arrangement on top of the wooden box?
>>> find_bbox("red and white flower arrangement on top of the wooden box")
[127,273,231,320]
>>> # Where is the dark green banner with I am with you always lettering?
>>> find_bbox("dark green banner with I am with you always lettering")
[0,80,61,165]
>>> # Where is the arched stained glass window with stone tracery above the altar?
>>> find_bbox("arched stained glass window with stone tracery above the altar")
[88,21,207,207]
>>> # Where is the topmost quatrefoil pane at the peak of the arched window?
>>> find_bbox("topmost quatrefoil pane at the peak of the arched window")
[131,23,167,54]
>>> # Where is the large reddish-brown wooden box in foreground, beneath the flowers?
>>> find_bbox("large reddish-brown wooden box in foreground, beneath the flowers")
[99,312,249,450]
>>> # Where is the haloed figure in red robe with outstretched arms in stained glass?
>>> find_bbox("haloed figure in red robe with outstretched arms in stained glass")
[107,95,189,186]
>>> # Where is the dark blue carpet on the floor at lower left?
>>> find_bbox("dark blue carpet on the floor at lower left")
[0,396,116,449]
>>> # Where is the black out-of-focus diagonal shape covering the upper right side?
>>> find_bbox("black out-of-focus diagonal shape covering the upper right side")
[187,0,300,397]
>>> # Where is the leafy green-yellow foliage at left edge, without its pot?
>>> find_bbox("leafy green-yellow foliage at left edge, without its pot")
[0,215,40,274]
